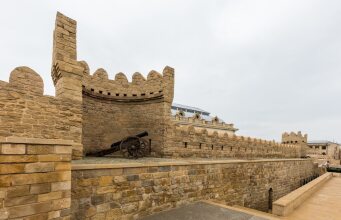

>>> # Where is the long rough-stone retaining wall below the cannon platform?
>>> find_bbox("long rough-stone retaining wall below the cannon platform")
[71,159,317,219]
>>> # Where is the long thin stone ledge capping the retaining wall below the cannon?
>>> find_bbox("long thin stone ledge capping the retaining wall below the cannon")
[71,158,310,170]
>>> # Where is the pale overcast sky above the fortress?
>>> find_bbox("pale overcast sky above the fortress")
[0,0,341,142]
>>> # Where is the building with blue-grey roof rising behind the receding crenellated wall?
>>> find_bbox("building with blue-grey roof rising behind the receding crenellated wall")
[171,103,238,135]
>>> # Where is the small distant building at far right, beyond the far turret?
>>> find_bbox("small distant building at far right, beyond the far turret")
[307,140,341,160]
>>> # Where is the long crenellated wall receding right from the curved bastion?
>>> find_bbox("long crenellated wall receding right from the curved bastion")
[164,126,301,158]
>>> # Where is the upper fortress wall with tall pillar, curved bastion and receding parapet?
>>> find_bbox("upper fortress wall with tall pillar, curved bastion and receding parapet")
[48,13,301,158]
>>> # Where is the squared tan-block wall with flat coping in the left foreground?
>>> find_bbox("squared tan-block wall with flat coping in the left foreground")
[0,137,73,220]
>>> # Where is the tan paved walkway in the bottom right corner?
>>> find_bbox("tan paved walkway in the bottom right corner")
[281,177,341,220]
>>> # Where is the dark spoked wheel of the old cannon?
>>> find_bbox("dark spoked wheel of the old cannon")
[120,136,150,159]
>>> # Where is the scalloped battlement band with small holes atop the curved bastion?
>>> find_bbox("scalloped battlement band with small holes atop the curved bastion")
[80,61,174,102]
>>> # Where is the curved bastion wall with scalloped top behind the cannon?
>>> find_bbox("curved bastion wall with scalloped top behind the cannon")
[82,62,174,156]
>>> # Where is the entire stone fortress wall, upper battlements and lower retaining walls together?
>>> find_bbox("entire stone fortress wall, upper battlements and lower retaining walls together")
[0,13,316,219]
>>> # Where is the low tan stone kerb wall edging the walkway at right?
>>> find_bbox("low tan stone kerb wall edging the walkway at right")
[272,173,333,216]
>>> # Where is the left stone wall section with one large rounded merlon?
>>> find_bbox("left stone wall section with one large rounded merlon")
[0,66,83,159]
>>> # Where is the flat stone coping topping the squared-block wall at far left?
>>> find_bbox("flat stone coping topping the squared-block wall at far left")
[0,137,75,145]
